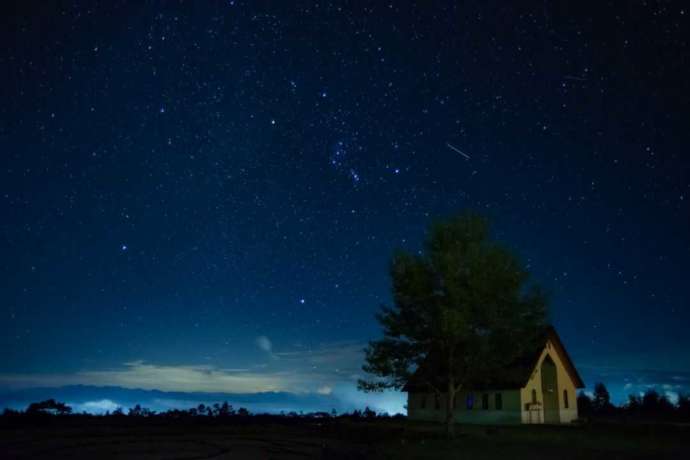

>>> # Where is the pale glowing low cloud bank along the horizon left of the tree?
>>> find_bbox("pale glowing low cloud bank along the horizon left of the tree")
[0,342,405,414]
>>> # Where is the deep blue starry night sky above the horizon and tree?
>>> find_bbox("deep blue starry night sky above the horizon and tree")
[0,0,690,410]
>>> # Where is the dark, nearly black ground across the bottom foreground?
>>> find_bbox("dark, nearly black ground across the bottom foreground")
[0,420,690,460]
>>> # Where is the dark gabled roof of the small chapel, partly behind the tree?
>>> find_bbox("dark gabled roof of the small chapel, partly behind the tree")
[402,326,585,392]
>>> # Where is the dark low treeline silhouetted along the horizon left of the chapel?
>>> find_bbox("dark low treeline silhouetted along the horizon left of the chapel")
[2,399,392,421]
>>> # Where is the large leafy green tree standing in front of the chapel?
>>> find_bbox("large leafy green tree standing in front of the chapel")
[359,214,546,437]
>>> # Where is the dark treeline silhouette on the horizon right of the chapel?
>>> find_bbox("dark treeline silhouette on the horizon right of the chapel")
[577,383,690,422]
